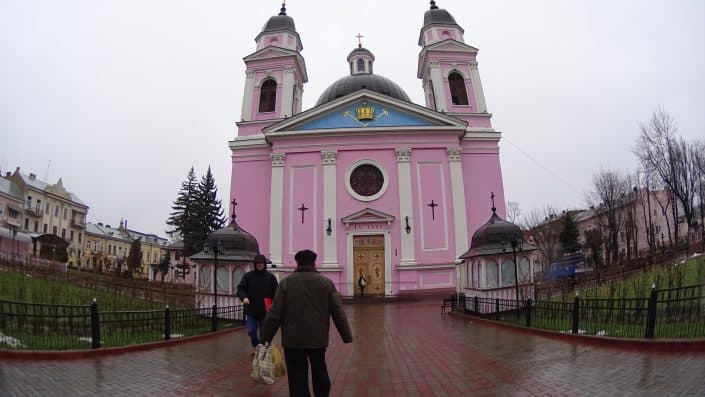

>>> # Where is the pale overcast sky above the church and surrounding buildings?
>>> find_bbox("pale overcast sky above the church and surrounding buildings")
[0,0,705,235]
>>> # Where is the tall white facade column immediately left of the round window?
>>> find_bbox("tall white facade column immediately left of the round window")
[321,150,338,267]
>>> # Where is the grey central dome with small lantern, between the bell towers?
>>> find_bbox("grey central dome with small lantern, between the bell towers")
[316,44,411,106]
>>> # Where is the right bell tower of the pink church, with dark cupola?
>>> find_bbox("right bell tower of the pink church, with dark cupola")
[417,1,487,120]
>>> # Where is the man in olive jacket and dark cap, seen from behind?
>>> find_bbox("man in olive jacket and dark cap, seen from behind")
[262,250,352,397]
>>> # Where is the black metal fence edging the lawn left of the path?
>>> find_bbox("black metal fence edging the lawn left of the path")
[0,301,244,350]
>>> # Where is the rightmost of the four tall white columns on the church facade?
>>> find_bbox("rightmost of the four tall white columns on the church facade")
[448,147,469,259]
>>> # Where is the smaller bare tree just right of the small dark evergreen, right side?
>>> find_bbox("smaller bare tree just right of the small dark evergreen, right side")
[586,169,630,264]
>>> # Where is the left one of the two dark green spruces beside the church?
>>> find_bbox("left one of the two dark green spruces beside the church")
[166,167,202,256]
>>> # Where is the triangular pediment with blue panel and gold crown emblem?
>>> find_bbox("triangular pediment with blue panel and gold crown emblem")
[264,90,466,136]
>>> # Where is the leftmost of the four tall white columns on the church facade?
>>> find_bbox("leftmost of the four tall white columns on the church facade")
[269,153,286,266]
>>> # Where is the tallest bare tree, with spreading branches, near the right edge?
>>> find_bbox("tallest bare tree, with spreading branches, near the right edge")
[633,108,697,242]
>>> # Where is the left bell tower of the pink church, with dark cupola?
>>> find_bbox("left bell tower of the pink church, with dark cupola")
[241,3,308,130]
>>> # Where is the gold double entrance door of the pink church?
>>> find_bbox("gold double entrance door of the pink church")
[353,235,385,296]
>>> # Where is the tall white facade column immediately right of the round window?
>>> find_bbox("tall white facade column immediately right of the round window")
[394,149,416,266]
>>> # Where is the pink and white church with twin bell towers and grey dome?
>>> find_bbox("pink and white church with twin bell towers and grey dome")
[229,1,505,297]
